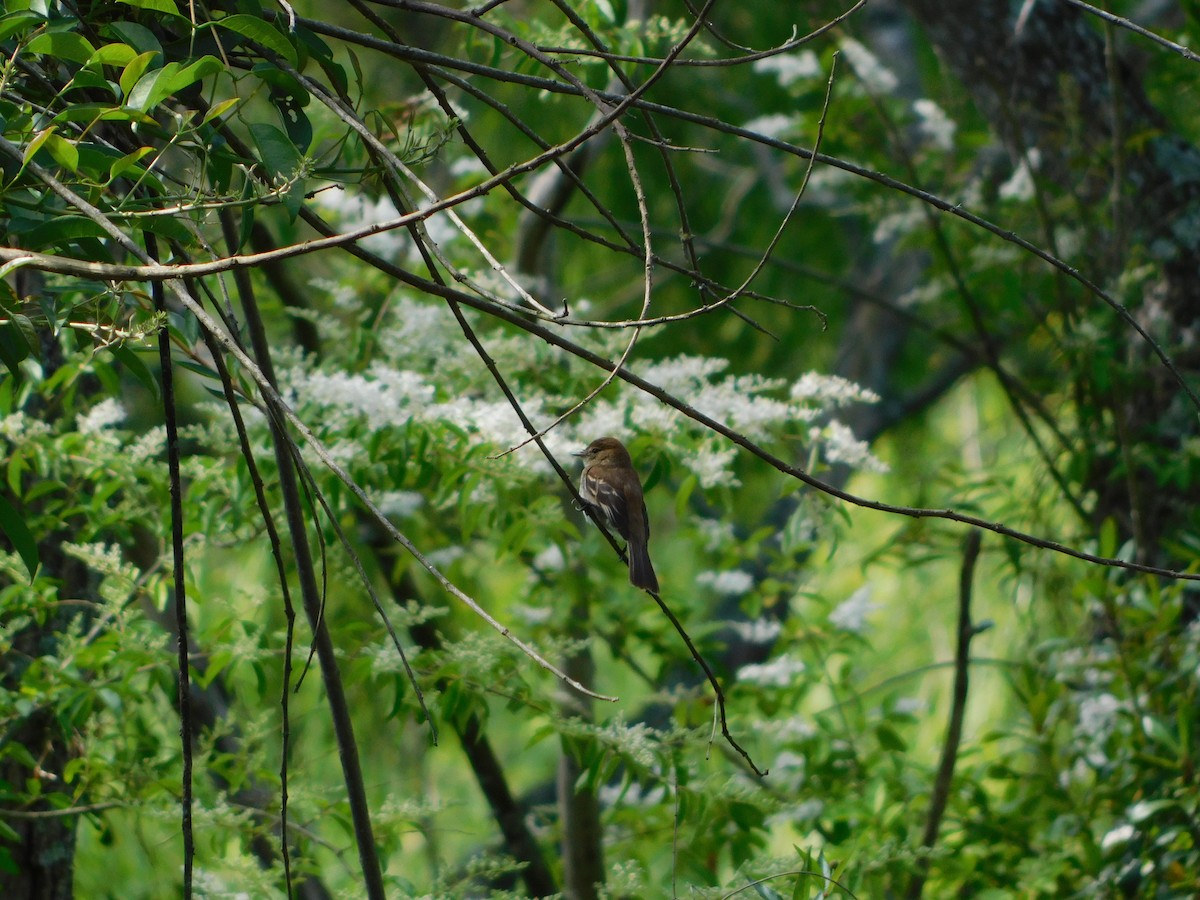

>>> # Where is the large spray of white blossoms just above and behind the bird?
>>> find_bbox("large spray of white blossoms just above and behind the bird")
[281,298,883,488]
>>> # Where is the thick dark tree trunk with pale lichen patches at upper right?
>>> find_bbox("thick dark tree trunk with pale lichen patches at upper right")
[905,0,1200,565]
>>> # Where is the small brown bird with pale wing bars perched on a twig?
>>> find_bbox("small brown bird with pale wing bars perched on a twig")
[574,438,659,593]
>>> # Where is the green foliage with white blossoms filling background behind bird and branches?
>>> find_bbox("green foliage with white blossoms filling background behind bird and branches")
[0,0,1200,898]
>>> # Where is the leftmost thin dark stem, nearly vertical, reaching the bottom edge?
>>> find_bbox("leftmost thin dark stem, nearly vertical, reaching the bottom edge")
[146,241,196,898]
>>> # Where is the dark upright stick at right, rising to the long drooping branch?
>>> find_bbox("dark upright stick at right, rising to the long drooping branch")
[906,530,982,900]
